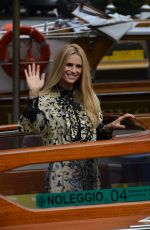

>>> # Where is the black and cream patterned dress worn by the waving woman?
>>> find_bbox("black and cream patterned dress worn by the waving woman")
[20,89,110,192]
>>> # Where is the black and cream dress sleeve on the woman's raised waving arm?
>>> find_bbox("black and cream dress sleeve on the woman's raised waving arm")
[19,97,47,132]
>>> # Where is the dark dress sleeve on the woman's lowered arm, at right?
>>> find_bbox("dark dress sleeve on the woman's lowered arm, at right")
[96,123,113,140]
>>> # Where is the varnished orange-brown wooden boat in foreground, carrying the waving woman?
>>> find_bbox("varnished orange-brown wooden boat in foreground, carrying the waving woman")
[0,117,150,230]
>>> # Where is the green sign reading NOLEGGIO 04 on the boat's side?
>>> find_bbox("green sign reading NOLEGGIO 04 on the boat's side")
[36,186,150,208]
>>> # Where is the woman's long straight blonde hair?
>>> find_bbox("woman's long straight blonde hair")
[41,44,101,127]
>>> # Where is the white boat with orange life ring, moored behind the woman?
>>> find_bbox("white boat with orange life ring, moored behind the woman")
[0,5,135,93]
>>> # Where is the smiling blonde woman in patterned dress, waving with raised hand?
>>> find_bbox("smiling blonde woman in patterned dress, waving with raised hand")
[20,44,134,192]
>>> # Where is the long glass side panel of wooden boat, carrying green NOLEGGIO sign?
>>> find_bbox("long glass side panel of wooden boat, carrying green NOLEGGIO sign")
[0,153,150,209]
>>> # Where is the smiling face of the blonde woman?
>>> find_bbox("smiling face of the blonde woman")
[59,54,82,90]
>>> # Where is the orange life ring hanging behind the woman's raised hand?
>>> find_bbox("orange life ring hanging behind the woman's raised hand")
[0,26,50,78]
